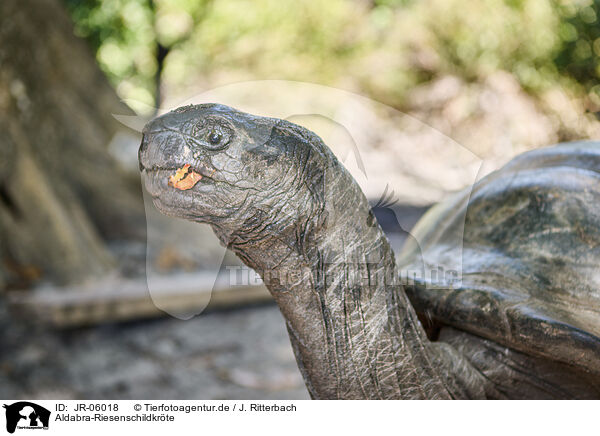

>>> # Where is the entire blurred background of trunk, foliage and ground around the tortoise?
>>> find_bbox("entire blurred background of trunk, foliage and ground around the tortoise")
[0,0,600,399]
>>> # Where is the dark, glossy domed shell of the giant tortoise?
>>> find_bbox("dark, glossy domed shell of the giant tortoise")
[397,142,600,374]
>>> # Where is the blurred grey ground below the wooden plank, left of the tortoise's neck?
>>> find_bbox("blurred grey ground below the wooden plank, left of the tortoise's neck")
[0,304,308,399]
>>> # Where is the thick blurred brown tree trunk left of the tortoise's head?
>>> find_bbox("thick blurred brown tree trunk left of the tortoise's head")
[0,0,145,287]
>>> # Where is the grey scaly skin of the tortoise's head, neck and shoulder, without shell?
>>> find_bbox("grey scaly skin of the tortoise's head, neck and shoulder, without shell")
[139,104,596,399]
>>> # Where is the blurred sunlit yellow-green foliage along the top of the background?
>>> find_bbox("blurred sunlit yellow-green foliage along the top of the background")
[65,0,600,114]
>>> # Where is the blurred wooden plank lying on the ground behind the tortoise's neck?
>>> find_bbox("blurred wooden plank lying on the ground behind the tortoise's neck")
[8,273,272,327]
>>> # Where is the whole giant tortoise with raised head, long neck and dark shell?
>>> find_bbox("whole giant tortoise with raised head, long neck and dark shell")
[139,104,600,399]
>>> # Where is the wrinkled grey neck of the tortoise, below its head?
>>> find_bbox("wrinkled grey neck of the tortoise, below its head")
[213,151,476,399]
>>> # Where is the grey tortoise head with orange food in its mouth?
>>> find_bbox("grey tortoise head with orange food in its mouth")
[139,104,331,244]
